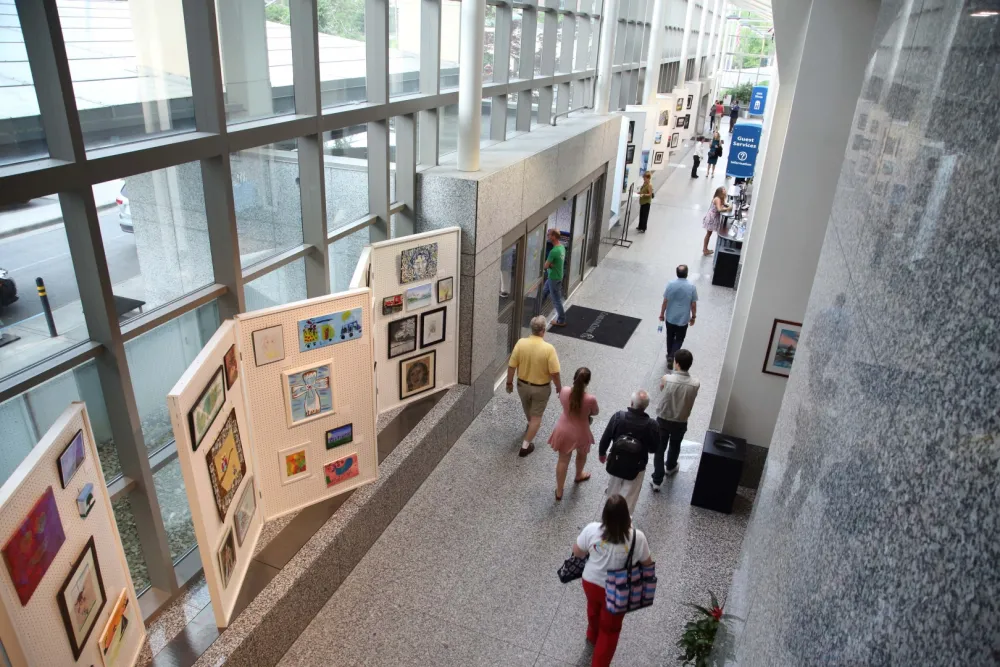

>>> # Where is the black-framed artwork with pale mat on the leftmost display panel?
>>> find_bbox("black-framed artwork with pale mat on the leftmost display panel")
[56,537,108,660]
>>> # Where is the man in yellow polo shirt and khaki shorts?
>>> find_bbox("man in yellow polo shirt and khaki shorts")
[507,315,562,456]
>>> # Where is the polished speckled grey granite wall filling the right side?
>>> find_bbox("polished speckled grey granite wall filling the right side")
[716,0,1000,667]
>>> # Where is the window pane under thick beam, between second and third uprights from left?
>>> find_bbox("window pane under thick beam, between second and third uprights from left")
[230,139,302,266]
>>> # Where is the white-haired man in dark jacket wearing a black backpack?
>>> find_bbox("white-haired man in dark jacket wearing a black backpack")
[598,389,660,514]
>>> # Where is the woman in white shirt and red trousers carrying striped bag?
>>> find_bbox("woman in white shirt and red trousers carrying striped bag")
[573,494,653,667]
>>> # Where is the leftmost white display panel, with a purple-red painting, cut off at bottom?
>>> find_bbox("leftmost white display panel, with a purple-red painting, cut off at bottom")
[0,403,146,667]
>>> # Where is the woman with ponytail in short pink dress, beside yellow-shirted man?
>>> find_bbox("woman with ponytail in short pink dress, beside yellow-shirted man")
[549,368,597,500]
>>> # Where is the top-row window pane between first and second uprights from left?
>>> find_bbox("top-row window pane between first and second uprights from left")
[57,0,194,148]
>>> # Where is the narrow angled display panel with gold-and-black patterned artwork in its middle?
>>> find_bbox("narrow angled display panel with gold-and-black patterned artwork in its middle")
[167,320,264,627]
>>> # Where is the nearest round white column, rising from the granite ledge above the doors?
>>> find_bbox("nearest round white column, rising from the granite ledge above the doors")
[458,0,486,171]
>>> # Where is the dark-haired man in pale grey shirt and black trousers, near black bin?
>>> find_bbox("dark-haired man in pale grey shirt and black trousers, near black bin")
[651,349,701,491]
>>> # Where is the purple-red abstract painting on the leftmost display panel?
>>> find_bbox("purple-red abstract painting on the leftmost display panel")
[3,486,66,606]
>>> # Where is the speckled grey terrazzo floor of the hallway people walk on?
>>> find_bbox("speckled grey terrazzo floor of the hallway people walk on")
[280,154,751,667]
